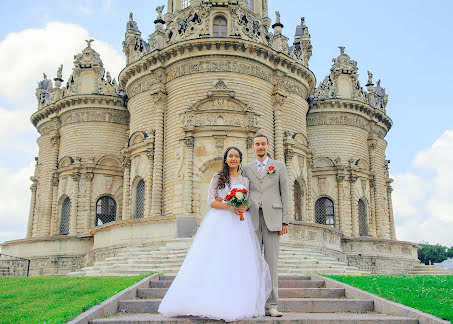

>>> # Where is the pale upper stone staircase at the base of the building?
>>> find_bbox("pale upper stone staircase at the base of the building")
[69,239,366,276]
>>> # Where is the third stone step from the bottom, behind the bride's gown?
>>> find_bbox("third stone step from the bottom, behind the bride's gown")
[137,288,345,299]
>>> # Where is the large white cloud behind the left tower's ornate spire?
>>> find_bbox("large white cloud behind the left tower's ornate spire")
[0,22,125,109]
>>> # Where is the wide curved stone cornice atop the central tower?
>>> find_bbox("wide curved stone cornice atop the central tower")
[119,38,316,93]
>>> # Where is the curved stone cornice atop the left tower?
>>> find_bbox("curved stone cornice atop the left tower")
[30,95,126,127]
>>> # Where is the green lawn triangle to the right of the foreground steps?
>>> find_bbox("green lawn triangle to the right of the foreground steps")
[327,275,453,321]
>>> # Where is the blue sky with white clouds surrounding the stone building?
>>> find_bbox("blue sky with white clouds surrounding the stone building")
[0,0,453,246]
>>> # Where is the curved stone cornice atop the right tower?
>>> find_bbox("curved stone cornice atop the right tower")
[307,99,393,132]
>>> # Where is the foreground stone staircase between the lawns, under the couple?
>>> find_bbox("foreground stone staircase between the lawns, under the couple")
[90,275,418,324]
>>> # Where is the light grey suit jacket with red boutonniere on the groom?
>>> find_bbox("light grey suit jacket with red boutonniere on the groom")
[242,158,289,231]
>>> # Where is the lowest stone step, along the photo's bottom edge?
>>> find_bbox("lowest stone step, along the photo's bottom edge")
[90,313,418,324]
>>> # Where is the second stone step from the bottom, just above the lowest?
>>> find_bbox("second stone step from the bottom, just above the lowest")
[118,298,374,313]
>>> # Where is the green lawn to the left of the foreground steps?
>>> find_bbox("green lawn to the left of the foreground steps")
[0,275,147,324]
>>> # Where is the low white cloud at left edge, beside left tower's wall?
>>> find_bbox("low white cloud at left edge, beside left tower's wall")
[0,162,34,243]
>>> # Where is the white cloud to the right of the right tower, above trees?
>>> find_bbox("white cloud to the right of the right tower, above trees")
[393,130,453,246]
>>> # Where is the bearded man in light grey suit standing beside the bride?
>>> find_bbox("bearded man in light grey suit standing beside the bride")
[242,134,289,317]
